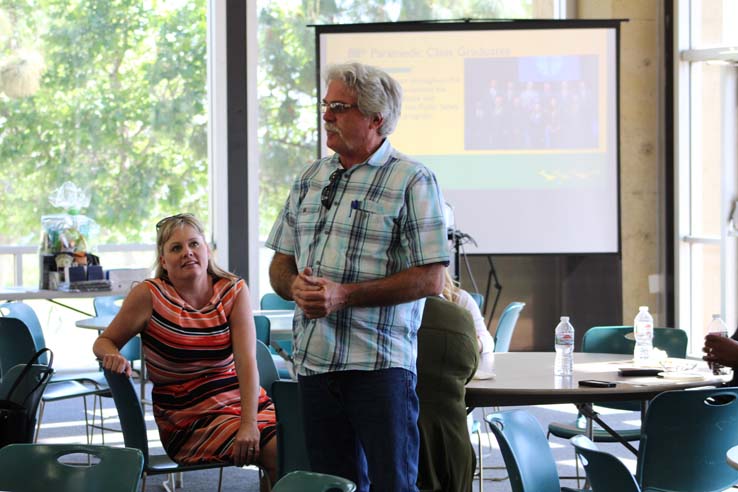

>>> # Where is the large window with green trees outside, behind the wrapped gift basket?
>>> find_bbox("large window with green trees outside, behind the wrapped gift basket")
[0,0,211,286]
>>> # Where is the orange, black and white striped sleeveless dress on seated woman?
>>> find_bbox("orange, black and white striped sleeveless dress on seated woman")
[141,279,276,464]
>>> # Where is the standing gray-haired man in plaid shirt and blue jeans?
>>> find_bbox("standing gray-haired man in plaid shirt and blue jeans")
[266,63,449,492]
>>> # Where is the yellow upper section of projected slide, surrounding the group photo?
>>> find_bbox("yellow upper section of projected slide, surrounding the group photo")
[320,28,614,155]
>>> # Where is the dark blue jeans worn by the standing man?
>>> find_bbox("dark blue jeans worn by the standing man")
[298,368,420,492]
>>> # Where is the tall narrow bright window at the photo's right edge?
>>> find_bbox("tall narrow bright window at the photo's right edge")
[675,0,738,354]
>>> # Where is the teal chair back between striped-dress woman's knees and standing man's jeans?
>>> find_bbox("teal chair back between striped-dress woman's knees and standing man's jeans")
[272,380,310,477]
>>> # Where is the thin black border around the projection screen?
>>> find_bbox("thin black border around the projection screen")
[311,19,627,259]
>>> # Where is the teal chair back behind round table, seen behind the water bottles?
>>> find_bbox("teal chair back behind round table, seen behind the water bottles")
[582,326,688,358]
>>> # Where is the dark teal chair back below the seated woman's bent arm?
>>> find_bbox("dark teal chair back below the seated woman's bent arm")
[105,369,149,468]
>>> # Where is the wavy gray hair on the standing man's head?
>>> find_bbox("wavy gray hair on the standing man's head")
[323,63,402,137]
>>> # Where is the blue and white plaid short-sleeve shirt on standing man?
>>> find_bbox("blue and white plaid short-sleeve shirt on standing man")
[266,139,449,375]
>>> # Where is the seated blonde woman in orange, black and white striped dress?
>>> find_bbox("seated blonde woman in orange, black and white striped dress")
[93,214,277,483]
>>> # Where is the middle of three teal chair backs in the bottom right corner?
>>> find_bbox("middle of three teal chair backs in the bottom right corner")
[570,435,641,492]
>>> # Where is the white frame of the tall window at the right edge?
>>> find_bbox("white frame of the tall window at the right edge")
[673,0,738,355]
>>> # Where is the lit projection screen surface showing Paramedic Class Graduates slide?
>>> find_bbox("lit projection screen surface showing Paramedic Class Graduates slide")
[317,23,620,254]
